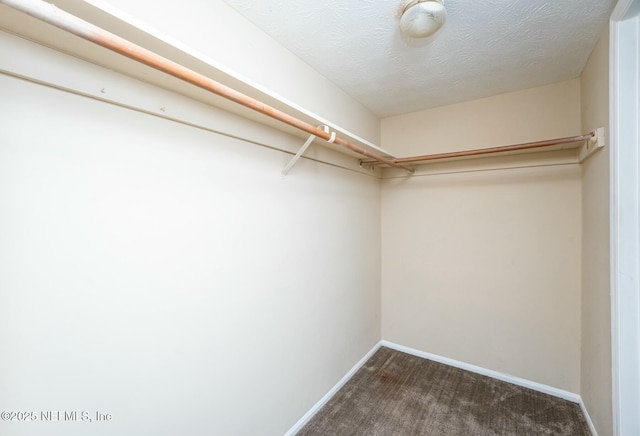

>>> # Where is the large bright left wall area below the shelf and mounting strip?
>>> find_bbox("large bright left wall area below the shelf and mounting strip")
[0,57,380,436]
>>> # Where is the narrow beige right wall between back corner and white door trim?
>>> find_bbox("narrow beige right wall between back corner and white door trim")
[581,28,613,436]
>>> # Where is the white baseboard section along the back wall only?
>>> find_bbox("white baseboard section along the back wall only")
[380,341,581,404]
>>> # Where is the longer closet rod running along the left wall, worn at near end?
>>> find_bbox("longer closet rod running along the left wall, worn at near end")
[0,0,414,173]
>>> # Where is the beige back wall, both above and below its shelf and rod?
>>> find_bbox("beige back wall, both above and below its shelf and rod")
[382,80,582,393]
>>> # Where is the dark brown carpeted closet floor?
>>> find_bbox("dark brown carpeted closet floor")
[298,347,591,436]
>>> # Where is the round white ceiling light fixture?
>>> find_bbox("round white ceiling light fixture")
[400,0,447,38]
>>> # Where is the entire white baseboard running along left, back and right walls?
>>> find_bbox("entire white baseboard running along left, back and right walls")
[284,340,598,436]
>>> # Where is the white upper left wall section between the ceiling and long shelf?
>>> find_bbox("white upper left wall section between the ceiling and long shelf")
[82,0,380,144]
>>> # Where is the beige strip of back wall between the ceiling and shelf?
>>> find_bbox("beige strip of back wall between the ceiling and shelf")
[381,79,581,156]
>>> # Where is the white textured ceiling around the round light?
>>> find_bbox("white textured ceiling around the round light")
[220,0,615,117]
